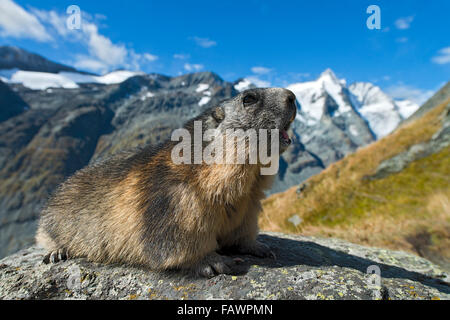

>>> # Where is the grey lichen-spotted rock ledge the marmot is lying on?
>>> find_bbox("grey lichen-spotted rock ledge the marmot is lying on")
[0,233,450,300]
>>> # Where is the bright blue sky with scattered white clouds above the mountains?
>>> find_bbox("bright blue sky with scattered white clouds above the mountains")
[0,0,450,102]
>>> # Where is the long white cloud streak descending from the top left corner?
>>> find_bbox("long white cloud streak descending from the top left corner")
[0,0,158,72]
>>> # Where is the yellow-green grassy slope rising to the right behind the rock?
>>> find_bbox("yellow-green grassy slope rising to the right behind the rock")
[260,99,450,266]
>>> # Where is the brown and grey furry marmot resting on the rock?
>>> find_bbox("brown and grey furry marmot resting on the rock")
[36,88,296,277]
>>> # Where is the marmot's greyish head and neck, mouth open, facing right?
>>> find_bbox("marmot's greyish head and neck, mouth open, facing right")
[178,88,297,169]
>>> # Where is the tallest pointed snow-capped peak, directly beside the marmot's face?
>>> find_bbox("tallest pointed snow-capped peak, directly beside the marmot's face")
[272,69,376,192]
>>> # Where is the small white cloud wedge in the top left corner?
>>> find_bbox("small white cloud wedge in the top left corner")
[0,0,52,42]
